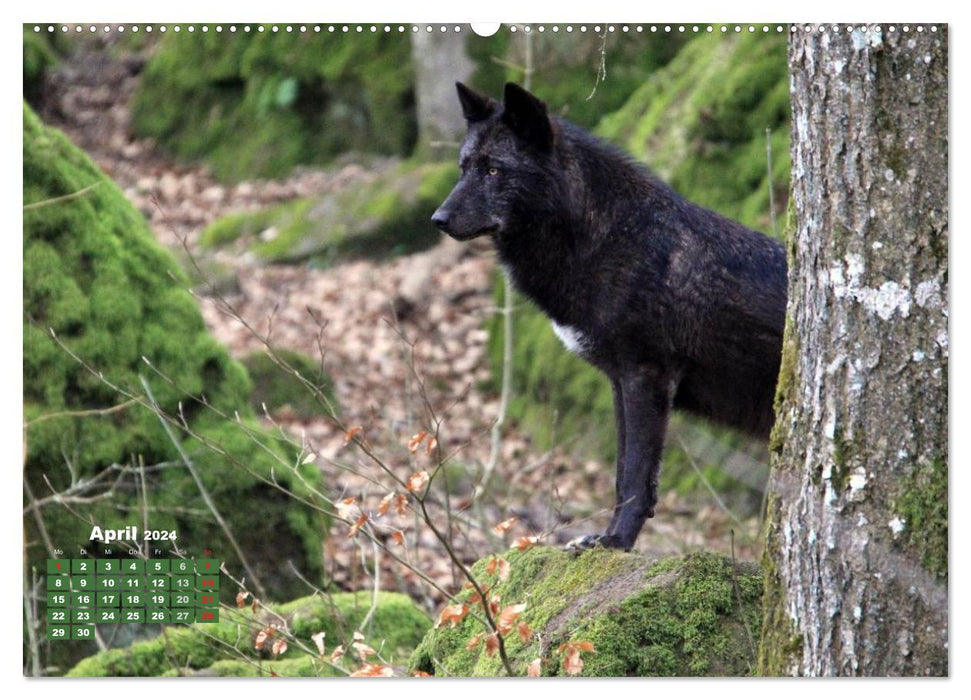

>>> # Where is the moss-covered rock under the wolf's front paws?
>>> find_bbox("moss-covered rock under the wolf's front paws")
[409,547,762,676]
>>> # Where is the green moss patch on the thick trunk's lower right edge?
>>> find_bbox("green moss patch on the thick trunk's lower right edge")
[894,459,948,583]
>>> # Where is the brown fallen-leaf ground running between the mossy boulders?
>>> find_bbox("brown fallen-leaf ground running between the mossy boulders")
[41,35,759,607]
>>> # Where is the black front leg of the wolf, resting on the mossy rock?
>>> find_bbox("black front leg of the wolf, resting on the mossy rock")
[567,366,677,552]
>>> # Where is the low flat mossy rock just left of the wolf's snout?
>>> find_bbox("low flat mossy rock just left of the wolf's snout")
[200,161,458,266]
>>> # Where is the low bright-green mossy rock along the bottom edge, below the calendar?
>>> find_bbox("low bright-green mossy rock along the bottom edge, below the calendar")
[67,592,431,677]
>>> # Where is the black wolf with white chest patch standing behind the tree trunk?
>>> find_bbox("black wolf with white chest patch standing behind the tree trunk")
[432,83,786,550]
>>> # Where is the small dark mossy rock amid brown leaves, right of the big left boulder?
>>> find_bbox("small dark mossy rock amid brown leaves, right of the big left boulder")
[242,350,337,418]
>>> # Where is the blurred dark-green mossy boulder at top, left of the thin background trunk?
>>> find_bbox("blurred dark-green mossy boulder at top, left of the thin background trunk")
[132,27,417,181]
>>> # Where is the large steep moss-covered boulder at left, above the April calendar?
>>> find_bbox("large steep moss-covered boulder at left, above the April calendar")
[23,105,326,628]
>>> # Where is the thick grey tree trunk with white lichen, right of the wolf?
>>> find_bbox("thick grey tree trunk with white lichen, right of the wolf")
[760,25,948,676]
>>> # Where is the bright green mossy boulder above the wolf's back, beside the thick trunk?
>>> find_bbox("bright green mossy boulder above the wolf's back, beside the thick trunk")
[597,34,790,234]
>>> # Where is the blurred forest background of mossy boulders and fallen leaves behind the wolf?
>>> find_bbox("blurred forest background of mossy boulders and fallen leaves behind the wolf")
[23,25,789,675]
